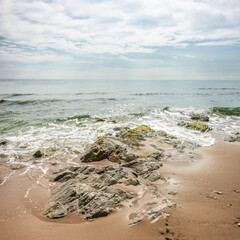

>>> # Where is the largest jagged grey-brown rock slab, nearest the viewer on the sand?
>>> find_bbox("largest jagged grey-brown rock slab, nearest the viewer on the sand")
[43,165,134,220]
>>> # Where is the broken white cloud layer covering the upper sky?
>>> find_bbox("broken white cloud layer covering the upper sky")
[0,0,240,79]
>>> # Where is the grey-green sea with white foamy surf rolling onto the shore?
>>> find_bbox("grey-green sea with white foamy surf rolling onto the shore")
[0,80,240,173]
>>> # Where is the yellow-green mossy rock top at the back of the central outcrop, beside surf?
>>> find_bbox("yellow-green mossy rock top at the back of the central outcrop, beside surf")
[121,125,154,140]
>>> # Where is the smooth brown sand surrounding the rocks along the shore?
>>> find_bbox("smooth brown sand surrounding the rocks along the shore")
[0,142,240,240]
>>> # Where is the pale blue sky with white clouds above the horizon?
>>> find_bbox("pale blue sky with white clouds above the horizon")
[0,0,240,80]
